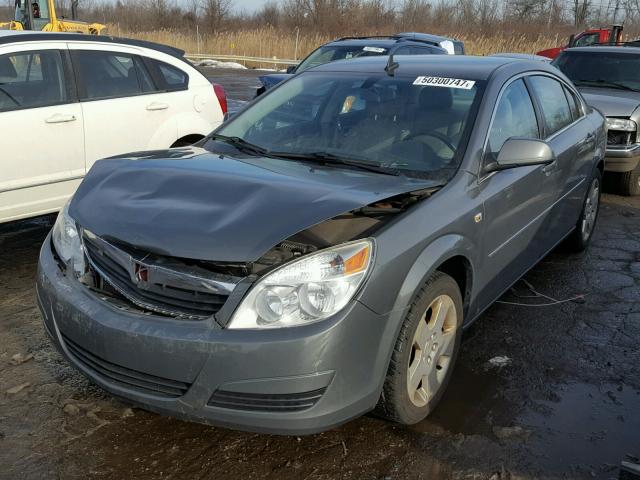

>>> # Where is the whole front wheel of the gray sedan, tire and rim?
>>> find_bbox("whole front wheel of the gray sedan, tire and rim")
[377,272,462,424]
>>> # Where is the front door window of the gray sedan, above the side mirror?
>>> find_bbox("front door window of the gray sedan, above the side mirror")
[489,79,539,160]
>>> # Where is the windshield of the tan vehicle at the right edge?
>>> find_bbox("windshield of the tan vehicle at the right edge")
[554,47,640,91]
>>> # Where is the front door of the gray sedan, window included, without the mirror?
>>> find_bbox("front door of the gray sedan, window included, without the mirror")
[474,78,549,313]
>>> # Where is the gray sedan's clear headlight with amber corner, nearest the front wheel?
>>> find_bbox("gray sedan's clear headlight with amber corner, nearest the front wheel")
[228,240,373,329]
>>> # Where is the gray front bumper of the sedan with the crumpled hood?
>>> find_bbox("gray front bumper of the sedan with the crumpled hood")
[37,237,393,435]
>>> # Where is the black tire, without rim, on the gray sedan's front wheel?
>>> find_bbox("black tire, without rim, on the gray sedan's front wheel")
[374,272,463,425]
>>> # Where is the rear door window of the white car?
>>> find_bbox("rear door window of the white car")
[74,51,156,100]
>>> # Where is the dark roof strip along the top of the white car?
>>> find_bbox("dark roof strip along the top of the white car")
[0,30,184,59]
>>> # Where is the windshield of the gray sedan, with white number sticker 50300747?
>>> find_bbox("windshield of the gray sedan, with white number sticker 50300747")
[205,72,483,180]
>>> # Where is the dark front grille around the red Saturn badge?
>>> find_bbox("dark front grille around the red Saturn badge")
[83,234,235,319]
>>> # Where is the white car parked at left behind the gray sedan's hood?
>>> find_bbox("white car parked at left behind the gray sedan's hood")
[0,31,226,223]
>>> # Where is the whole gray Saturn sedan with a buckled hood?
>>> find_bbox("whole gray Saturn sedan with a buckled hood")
[37,55,606,434]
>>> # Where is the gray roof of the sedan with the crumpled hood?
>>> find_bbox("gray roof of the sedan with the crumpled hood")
[308,55,544,80]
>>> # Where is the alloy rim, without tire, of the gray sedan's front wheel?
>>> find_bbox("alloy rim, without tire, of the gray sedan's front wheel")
[407,295,458,407]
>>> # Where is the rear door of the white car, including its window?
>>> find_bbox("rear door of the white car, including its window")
[69,42,177,169]
